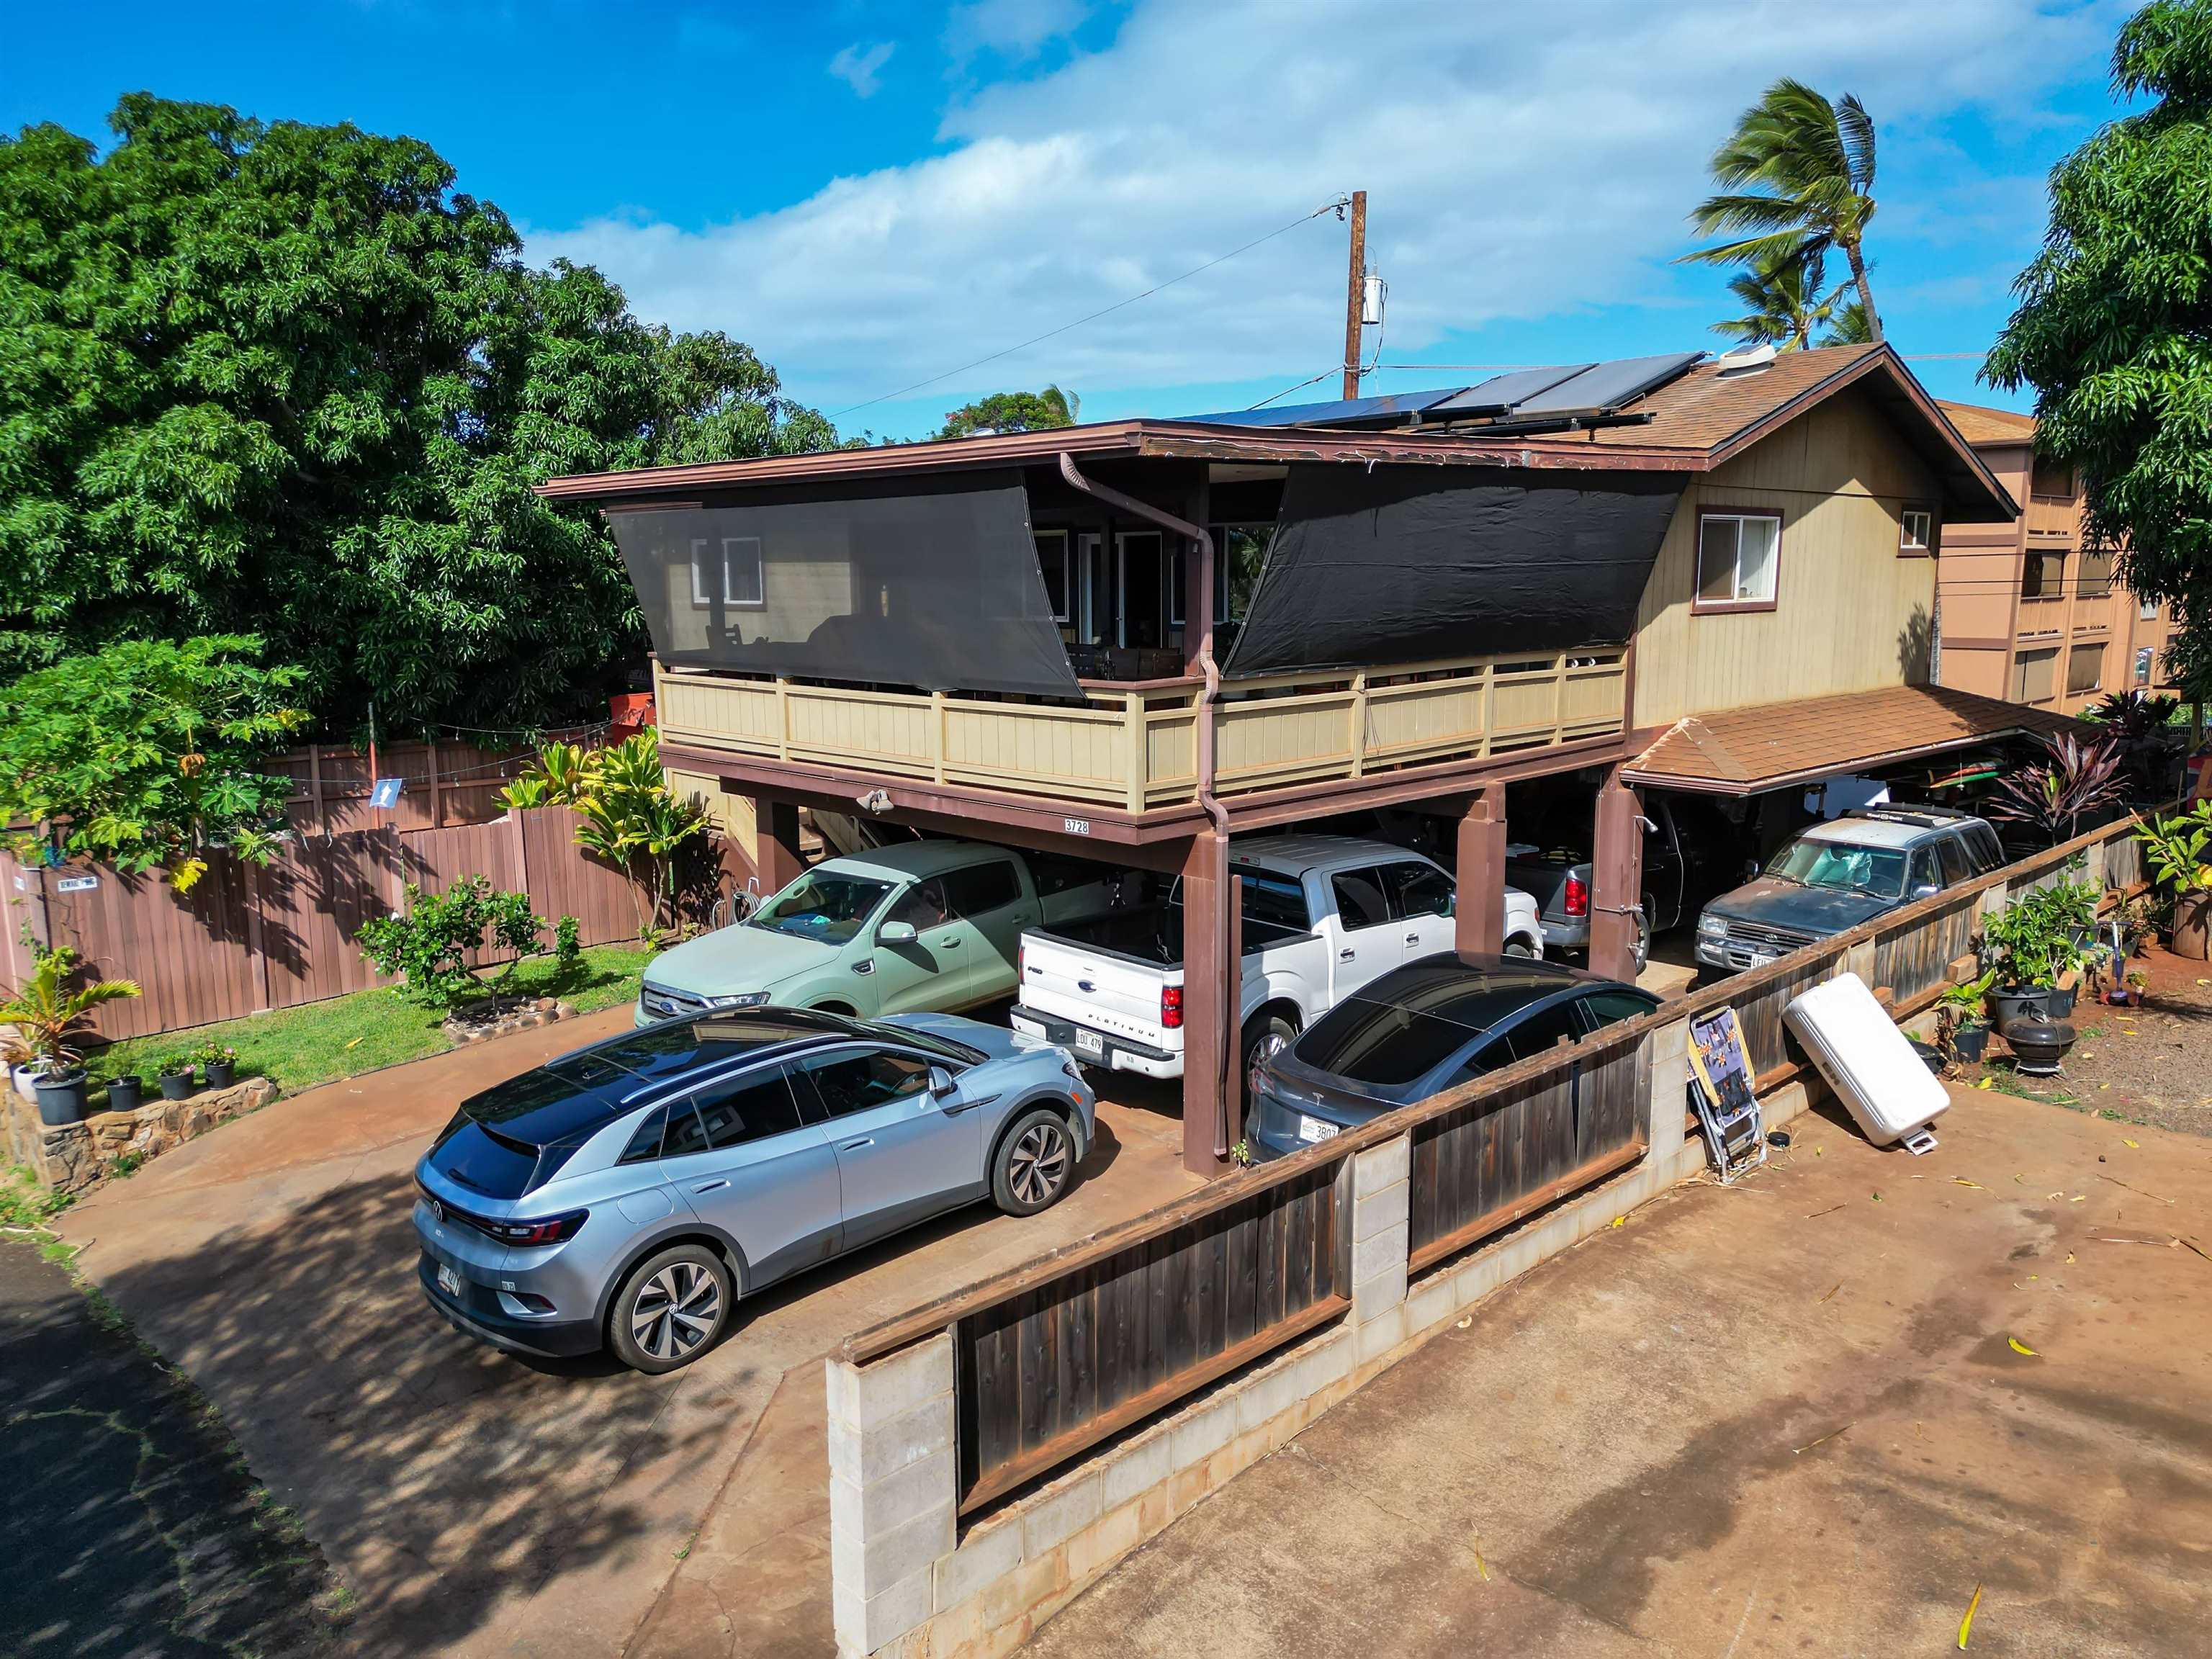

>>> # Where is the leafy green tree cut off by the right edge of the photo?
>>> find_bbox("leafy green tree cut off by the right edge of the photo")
[1982,0,2212,729]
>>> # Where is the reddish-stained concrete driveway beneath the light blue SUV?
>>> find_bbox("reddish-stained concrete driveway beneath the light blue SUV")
[62,1009,1192,1659]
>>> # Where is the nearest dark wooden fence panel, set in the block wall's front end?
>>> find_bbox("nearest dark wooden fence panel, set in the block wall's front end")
[951,1166,1352,1511]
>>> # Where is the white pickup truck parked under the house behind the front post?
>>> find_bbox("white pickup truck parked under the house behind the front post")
[1009,836,1544,1092]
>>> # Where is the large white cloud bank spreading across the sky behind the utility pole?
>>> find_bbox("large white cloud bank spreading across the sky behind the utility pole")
[531,0,2119,425]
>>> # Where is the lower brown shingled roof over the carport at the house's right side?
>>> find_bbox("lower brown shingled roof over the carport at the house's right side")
[1624,685,2080,794]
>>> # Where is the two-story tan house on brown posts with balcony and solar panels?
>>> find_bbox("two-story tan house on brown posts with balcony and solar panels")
[544,347,2041,1168]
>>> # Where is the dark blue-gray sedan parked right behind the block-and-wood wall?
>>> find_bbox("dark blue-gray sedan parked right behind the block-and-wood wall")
[1246,953,1659,1164]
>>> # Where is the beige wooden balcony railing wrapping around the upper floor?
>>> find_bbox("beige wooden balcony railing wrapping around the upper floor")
[655,646,1628,811]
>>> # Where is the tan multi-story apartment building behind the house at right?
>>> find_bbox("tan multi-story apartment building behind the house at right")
[1938,403,2172,714]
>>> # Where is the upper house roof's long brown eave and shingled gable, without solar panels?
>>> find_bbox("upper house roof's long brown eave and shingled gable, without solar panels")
[537,345,2020,522]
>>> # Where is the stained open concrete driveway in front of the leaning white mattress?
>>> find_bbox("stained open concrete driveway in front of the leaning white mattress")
[1031,1090,2212,1659]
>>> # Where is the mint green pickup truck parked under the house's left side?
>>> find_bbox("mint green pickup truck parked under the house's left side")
[637,840,1148,1024]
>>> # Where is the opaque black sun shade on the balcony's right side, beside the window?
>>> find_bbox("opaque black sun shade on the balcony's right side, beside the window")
[1226,464,1681,675]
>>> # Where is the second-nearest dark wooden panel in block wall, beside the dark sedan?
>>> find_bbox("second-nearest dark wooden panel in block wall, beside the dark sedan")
[1407,1033,1650,1272]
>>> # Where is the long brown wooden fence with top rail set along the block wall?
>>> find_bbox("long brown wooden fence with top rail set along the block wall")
[842,819,2141,1513]
